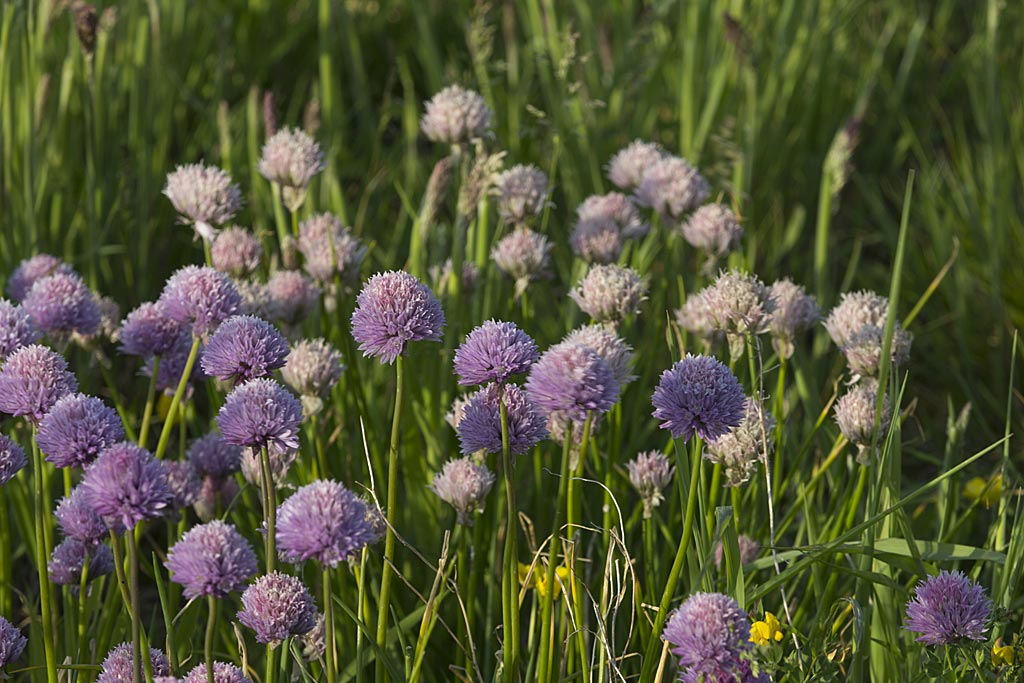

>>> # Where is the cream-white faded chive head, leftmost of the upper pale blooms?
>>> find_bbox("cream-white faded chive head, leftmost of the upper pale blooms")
[164,163,242,242]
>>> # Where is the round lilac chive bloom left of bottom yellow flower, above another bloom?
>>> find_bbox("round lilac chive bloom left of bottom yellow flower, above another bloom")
[662,593,751,669]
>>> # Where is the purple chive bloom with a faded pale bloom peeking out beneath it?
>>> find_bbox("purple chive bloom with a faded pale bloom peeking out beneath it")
[217,379,302,453]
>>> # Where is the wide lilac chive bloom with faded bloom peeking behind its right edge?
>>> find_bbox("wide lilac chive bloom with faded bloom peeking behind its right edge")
[278,479,378,567]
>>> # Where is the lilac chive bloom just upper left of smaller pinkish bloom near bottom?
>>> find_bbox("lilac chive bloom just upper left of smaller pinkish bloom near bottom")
[164,519,256,600]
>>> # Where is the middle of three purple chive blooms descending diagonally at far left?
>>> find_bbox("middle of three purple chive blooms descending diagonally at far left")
[37,393,125,467]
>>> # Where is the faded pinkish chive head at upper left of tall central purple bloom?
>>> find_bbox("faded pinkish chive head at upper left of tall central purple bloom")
[299,213,367,284]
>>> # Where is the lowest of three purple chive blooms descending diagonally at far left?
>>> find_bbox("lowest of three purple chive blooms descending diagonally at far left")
[80,441,171,530]
